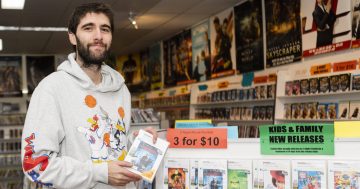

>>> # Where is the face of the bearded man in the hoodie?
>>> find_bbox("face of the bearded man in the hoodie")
[69,13,112,66]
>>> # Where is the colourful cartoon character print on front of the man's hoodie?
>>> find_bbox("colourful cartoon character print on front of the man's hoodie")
[77,95,126,163]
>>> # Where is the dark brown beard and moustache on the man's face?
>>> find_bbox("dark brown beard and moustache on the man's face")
[76,36,110,68]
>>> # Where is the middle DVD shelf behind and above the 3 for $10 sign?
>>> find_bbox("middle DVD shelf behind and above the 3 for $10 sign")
[190,73,276,135]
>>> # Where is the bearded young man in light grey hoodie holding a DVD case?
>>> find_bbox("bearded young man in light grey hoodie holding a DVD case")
[21,3,157,188]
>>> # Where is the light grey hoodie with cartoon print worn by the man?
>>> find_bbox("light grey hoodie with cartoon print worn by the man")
[21,54,131,188]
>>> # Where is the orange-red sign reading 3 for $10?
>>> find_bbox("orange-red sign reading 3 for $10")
[166,128,227,148]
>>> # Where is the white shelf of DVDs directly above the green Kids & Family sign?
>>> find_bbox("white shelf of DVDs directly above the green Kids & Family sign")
[275,69,360,123]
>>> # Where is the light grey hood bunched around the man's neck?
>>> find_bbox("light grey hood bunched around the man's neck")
[57,53,125,92]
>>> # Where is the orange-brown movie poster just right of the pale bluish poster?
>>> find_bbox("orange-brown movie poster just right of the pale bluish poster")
[210,8,236,78]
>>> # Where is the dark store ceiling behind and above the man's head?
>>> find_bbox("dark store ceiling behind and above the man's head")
[0,0,241,55]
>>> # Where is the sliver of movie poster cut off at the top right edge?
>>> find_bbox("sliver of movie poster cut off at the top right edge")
[351,0,360,48]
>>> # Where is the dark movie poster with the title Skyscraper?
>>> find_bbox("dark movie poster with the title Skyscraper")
[265,0,304,68]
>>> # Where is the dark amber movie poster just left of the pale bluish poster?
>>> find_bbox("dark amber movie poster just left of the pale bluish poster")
[163,30,195,87]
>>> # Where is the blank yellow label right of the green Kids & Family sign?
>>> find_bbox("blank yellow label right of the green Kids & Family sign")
[334,121,360,138]
